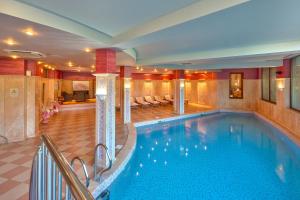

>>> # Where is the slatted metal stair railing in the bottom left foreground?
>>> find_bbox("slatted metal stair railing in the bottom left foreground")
[29,135,94,200]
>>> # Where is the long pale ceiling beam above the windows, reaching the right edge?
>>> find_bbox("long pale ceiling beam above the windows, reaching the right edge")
[137,40,300,65]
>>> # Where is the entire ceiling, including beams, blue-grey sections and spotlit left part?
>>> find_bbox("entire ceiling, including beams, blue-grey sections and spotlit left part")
[0,0,300,69]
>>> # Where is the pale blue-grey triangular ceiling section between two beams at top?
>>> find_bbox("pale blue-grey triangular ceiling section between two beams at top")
[19,0,197,36]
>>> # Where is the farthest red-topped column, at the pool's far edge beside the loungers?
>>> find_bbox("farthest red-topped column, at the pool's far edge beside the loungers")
[173,70,184,115]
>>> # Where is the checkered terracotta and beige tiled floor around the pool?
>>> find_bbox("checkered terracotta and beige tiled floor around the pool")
[0,105,208,200]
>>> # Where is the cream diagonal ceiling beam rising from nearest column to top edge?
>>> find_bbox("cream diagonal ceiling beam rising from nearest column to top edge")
[113,0,250,45]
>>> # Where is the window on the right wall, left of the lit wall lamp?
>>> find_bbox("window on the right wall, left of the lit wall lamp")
[261,67,276,103]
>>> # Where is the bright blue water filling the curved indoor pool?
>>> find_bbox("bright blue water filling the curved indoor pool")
[109,113,300,200]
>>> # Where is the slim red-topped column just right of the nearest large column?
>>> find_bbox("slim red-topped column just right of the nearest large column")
[120,66,131,124]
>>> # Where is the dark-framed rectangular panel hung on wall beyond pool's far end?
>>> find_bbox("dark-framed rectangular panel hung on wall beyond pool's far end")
[229,73,244,99]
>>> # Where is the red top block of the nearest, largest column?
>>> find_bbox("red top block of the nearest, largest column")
[96,49,116,73]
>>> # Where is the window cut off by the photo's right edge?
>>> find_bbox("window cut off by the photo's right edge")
[291,56,300,111]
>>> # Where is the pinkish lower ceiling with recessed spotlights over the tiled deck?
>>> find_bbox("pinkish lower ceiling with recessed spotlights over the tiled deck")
[0,14,135,71]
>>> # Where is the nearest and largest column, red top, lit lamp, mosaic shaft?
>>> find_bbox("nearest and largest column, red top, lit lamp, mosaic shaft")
[94,49,117,167]
